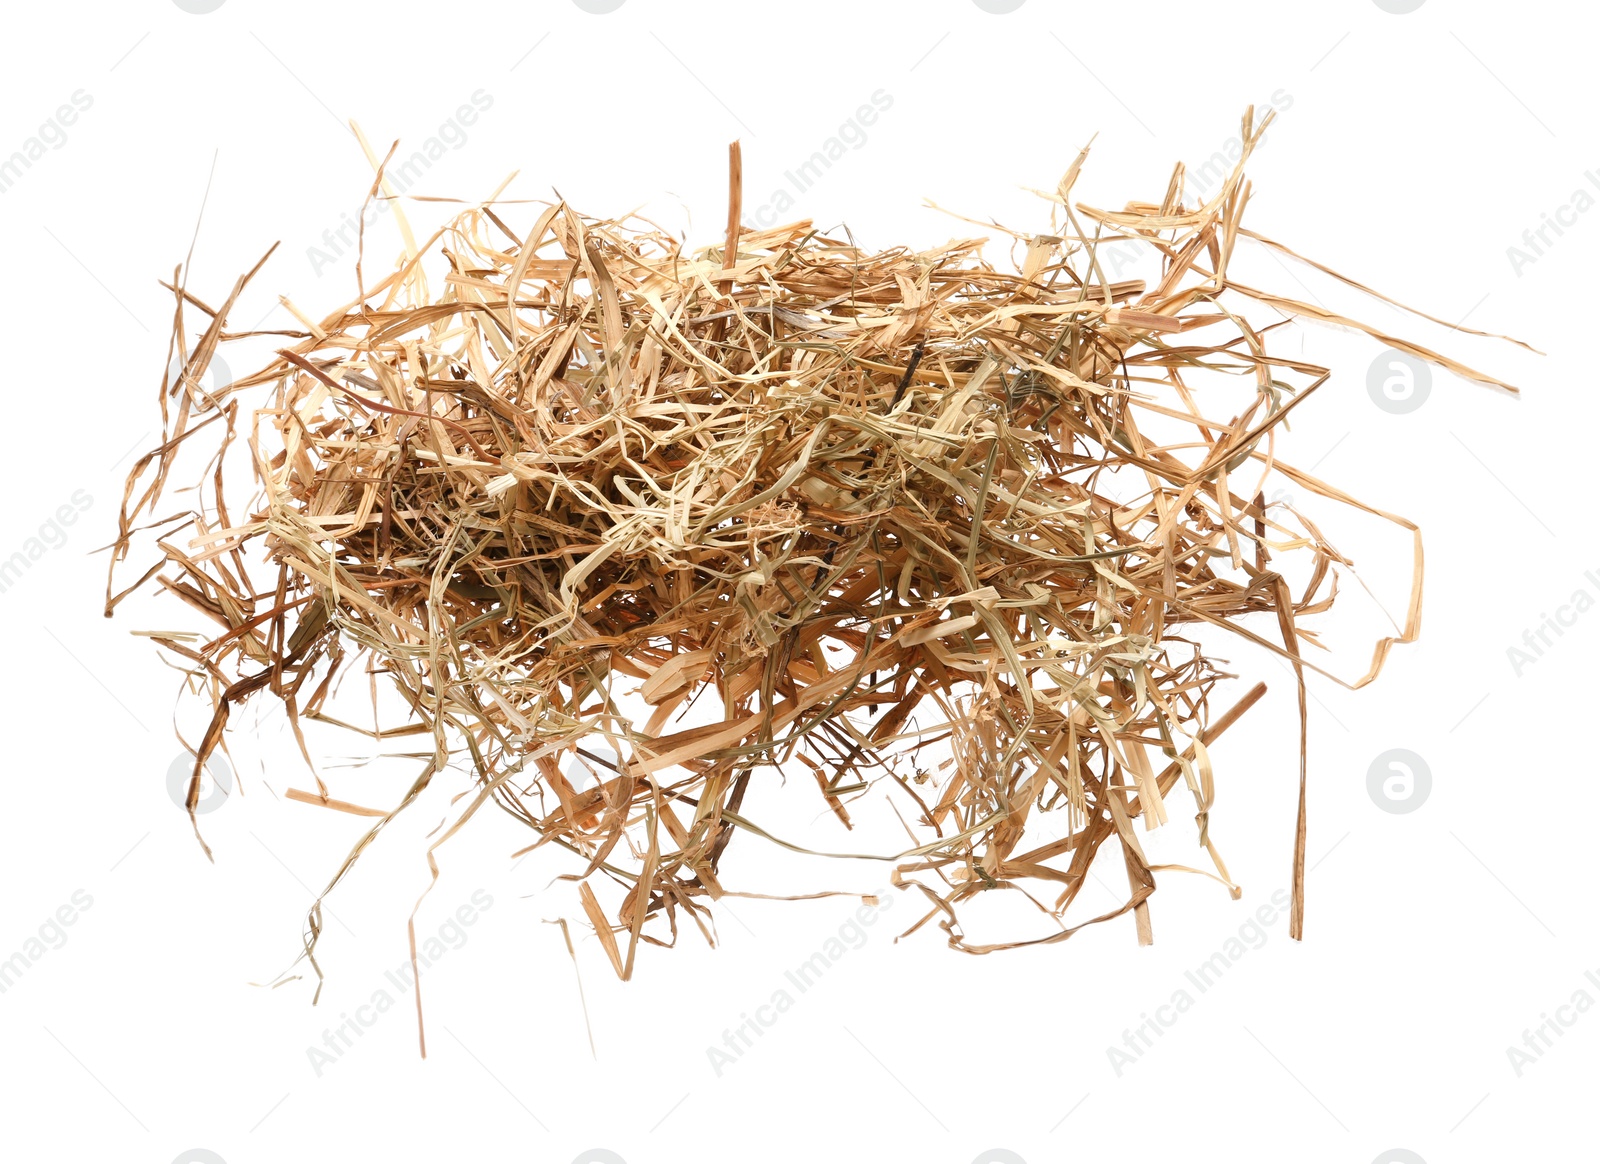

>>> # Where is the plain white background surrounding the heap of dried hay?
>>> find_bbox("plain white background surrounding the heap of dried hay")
[0,0,1600,1164]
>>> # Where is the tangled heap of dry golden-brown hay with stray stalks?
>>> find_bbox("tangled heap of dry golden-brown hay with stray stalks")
[107,115,1509,977]
